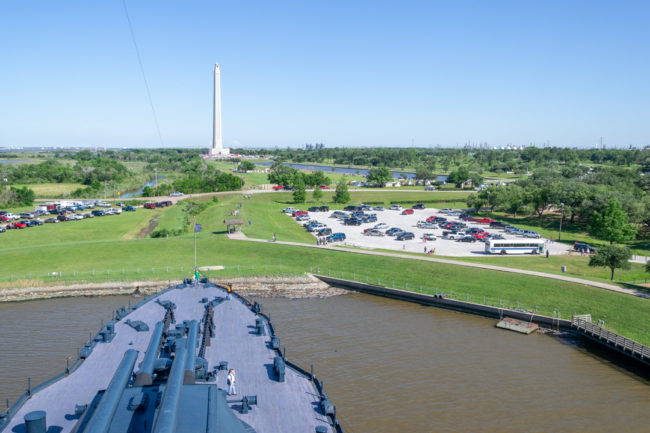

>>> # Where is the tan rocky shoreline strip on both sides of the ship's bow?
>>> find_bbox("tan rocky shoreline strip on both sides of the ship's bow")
[0,275,348,303]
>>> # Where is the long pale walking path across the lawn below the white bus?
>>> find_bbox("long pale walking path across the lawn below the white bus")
[228,231,650,299]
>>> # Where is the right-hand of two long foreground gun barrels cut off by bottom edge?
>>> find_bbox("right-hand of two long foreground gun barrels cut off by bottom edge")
[153,341,187,433]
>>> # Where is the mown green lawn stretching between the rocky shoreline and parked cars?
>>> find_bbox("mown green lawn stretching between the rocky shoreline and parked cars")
[0,191,650,344]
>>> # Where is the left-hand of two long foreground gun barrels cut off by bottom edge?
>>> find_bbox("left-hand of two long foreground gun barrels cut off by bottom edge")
[84,349,138,433]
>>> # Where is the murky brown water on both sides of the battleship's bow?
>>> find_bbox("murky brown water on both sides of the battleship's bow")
[0,294,650,433]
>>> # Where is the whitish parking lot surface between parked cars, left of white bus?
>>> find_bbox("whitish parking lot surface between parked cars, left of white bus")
[299,209,568,257]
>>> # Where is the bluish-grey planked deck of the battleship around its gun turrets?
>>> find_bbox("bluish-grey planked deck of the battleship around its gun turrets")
[0,283,340,433]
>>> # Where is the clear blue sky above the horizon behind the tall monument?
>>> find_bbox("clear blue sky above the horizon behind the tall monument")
[0,0,650,147]
